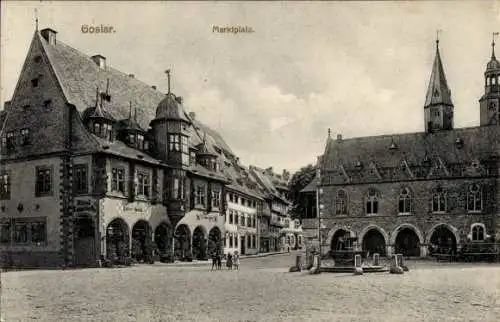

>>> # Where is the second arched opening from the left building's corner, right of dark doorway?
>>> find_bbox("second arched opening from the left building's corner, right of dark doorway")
[106,218,130,261]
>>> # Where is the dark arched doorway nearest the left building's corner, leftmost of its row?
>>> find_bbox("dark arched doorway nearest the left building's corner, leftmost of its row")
[74,216,97,266]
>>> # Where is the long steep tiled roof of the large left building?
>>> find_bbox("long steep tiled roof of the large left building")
[28,33,270,198]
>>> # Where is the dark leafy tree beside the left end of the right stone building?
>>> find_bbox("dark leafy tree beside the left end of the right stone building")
[287,164,316,219]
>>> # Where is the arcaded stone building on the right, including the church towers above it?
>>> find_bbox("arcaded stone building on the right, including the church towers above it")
[303,42,500,257]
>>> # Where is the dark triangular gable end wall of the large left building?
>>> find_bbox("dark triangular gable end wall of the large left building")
[3,32,69,158]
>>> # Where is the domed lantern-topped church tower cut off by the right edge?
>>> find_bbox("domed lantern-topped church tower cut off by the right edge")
[479,33,500,126]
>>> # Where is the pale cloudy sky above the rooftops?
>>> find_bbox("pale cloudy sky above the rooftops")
[0,1,500,171]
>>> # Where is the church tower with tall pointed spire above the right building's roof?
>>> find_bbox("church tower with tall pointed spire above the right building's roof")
[424,39,453,132]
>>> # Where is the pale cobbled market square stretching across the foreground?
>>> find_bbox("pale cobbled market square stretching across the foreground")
[1,253,500,322]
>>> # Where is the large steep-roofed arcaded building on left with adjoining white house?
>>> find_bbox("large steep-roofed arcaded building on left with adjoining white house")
[0,28,296,267]
